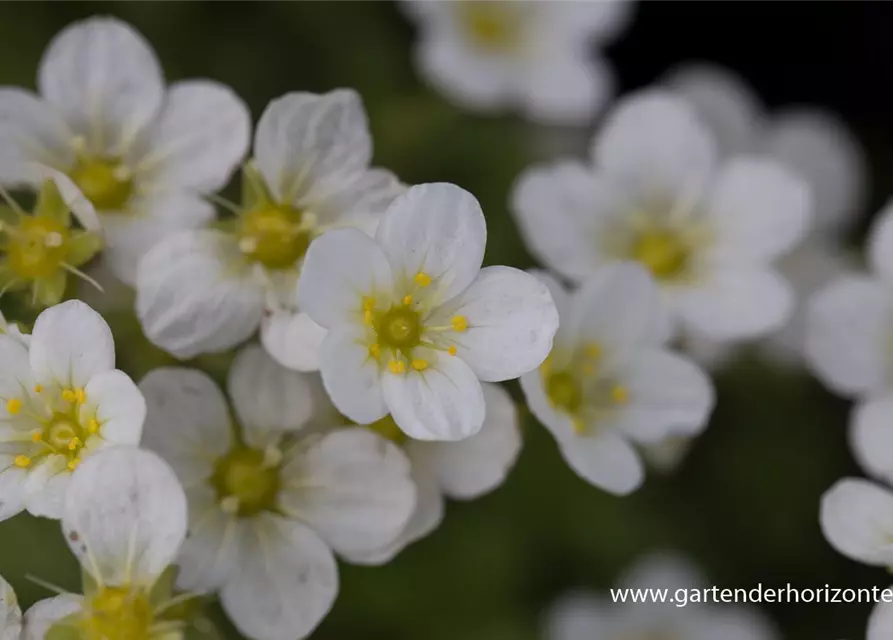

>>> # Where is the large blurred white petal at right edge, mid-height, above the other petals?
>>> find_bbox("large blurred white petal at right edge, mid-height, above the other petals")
[806,277,893,395]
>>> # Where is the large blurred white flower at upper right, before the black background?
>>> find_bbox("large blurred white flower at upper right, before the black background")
[513,91,810,340]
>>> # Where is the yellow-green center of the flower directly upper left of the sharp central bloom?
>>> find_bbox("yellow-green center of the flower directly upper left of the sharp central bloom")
[237,203,312,269]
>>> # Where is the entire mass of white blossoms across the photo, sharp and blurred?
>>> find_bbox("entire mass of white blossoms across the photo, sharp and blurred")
[0,0,880,640]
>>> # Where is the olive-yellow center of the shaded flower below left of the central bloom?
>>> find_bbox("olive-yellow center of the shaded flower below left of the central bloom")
[211,446,281,517]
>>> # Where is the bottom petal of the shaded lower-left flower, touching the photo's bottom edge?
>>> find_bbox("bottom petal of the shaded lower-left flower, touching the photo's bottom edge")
[220,516,338,640]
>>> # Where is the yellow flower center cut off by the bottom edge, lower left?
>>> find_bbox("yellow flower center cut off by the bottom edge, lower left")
[83,587,152,640]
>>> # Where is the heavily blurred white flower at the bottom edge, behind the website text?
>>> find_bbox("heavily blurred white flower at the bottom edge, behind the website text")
[544,555,779,640]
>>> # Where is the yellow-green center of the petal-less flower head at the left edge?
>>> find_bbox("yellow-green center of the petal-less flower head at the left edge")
[3,216,69,280]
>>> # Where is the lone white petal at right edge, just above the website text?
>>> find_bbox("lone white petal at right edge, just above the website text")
[820,478,893,567]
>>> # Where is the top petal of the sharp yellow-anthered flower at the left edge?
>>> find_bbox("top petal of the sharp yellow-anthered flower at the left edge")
[31,300,115,388]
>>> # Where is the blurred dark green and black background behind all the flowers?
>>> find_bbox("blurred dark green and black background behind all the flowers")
[0,0,880,640]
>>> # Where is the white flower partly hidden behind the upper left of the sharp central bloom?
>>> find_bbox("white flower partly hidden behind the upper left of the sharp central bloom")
[136,90,401,370]
